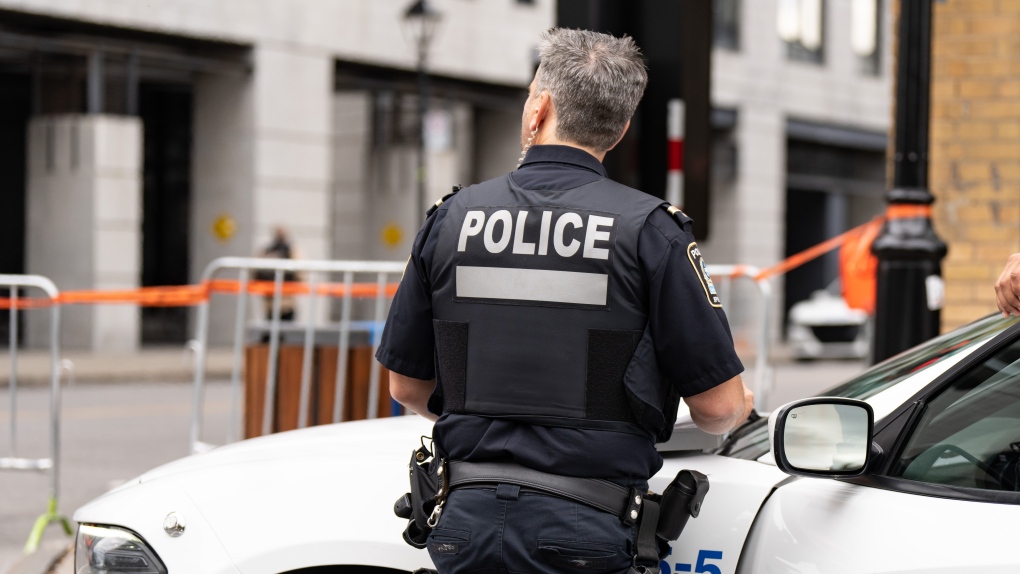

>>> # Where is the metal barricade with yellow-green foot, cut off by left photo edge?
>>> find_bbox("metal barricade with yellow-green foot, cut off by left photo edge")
[0,274,71,554]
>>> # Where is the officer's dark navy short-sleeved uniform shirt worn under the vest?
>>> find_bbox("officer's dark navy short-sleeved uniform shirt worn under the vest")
[375,146,744,486]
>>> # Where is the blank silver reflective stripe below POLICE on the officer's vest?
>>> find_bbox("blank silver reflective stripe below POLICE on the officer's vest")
[457,265,609,305]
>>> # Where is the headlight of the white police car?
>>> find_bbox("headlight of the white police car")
[74,524,166,574]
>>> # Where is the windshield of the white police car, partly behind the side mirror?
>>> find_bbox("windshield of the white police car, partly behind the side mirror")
[715,315,1020,460]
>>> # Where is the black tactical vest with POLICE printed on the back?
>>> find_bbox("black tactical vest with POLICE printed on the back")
[427,176,679,440]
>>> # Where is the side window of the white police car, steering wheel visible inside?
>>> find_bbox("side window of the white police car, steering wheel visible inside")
[890,341,1020,491]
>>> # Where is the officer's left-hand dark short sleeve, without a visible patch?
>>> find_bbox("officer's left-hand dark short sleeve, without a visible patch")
[375,209,446,380]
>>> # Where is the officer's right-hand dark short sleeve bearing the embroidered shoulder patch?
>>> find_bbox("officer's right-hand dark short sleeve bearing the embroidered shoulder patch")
[639,209,744,397]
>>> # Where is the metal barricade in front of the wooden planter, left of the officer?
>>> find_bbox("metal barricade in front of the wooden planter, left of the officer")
[190,257,405,453]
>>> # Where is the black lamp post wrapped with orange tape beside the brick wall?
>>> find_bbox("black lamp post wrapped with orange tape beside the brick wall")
[871,0,947,363]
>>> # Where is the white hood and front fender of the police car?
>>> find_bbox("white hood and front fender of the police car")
[74,416,785,574]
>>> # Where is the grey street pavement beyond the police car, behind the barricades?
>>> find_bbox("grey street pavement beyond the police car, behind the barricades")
[0,360,864,574]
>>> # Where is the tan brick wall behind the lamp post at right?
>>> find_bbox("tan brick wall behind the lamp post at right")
[929,0,1020,330]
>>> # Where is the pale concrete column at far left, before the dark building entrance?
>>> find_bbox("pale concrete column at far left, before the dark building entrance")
[27,115,142,352]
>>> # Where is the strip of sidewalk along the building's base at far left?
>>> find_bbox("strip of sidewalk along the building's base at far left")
[0,347,233,386]
